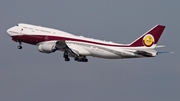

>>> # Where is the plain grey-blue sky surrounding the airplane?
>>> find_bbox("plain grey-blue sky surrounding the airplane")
[0,0,180,101]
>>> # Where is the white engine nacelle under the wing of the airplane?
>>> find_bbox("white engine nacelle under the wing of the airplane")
[38,43,56,53]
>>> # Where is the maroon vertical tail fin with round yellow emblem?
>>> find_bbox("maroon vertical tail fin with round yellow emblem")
[130,25,165,47]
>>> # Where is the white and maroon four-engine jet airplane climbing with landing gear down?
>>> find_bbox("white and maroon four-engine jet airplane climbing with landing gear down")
[7,23,169,62]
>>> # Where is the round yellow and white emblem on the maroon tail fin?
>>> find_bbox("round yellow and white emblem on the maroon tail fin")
[143,34,154,47]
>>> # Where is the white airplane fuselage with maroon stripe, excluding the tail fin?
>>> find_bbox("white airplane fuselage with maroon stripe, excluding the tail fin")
[7,23,160,59]
